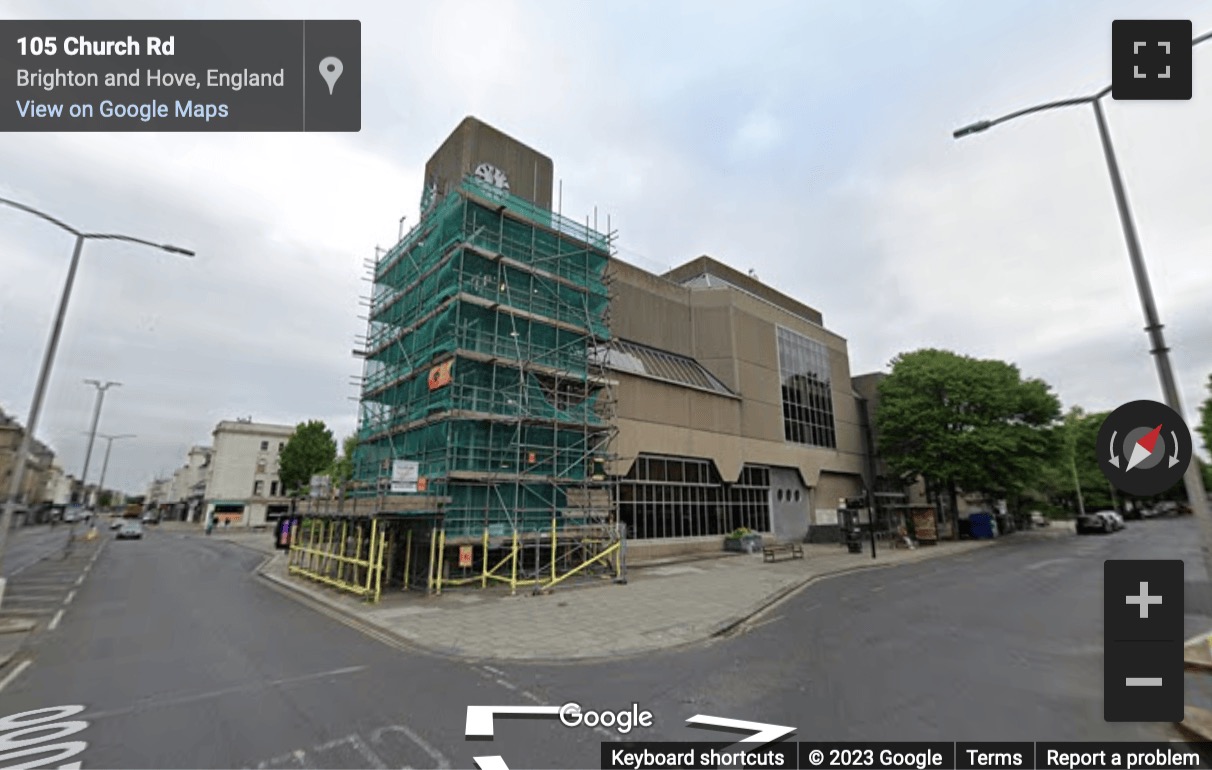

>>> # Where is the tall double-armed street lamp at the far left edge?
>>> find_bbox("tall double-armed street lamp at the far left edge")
[0,198,194,603]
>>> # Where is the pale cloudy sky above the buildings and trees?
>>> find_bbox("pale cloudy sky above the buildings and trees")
[0,0,1212,494]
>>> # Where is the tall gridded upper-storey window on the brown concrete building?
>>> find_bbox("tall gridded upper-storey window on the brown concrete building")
[778,327,837,449]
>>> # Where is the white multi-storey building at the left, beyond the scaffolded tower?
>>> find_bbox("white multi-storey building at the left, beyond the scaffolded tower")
[201,420,295,526]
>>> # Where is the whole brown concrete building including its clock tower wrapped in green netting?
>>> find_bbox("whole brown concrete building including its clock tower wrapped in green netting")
[346,118,865,569]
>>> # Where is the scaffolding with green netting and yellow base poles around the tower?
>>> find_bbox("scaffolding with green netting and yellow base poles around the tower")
[292,177,625,595]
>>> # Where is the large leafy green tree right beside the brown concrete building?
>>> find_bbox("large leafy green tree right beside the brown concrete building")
[875,349,1064,531]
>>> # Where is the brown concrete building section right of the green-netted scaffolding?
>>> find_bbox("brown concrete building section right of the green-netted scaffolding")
[606,256,864,549]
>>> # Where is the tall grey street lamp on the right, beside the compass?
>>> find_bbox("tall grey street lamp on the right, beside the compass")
[953,32,1212,575]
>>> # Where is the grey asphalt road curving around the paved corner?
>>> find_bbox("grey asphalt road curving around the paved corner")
[0,520,1205,769]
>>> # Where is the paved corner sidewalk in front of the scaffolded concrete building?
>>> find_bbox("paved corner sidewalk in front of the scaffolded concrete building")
[261,523,1074,662]
